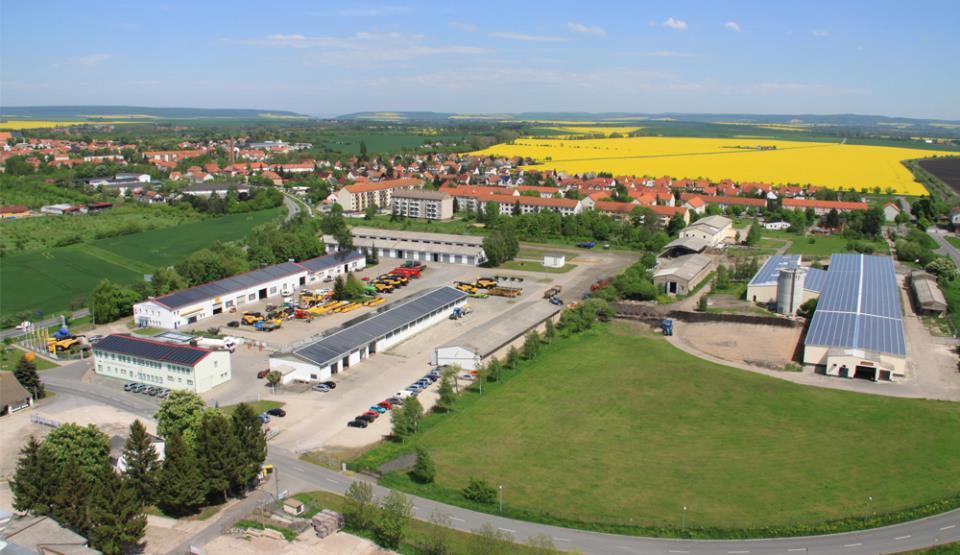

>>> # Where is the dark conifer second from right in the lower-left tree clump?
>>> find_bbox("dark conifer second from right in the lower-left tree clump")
[197,411,242,500]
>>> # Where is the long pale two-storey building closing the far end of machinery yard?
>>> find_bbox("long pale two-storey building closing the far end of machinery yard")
[323,227,487,266]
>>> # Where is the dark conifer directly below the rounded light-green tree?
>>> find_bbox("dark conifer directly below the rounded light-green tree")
[157,430,207,516]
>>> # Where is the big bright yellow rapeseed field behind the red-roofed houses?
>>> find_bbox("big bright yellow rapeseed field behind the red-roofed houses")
[474,137,934,195]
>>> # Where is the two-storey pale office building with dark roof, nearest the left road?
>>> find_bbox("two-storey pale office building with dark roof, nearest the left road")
[93,335,233,393]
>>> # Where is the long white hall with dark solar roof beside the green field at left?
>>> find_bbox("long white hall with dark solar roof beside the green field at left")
[133,252,366,329]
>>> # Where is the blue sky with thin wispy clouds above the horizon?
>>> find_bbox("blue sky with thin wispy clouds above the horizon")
[0,0,960,119]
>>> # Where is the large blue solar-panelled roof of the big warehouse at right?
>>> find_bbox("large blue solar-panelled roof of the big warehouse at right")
[804,254,907,356]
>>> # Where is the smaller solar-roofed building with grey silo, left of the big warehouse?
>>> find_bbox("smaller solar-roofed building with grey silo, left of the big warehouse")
[747,254,827,314]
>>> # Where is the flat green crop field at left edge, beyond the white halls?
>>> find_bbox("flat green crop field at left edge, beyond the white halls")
[0,208,282,317]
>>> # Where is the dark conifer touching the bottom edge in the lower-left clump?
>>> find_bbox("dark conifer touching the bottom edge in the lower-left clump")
[90,474,147,555]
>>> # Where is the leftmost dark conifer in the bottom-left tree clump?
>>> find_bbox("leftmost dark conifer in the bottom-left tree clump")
[10,436,57,515]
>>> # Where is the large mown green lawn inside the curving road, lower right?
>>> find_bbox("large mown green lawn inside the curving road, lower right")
[355,322,960,533]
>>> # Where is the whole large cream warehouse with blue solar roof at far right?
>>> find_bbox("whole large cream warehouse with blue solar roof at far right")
[803,254,907,381]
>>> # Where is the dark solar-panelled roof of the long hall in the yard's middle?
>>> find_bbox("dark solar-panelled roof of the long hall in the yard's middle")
[293,287,467,366]
